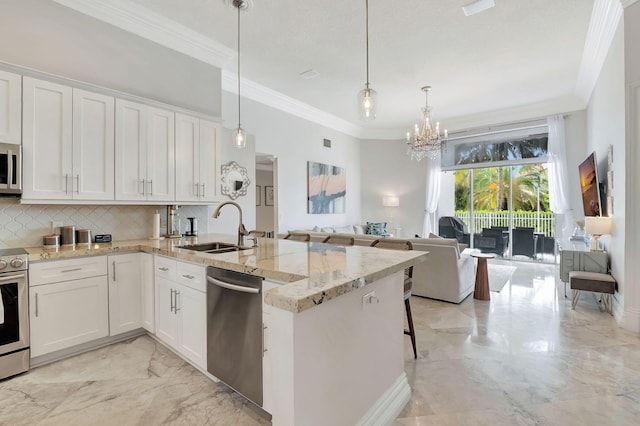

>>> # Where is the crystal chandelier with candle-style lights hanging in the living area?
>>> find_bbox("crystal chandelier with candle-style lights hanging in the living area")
[407,86,447,161]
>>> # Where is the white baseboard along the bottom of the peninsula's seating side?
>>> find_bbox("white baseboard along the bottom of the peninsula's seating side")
[357,371,411,426]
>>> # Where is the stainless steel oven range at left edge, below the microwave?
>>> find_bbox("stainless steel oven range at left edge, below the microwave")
[0,249,30,379]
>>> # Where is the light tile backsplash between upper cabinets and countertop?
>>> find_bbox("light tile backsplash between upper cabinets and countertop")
[0,198,208,248]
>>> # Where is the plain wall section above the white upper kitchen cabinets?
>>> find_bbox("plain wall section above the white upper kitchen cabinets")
[0,0,221,117]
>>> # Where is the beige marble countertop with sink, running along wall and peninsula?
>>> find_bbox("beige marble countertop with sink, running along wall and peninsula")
[26,234,428,313]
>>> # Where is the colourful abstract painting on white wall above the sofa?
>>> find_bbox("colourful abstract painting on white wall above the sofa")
[307,161,347,214]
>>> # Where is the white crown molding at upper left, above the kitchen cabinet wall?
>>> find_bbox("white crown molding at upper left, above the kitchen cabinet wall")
[54,0,236,68]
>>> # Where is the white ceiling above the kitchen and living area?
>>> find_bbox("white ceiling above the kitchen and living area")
[59,0,594,138]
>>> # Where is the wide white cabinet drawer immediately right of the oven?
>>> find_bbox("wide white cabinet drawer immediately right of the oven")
[29,256,107,287]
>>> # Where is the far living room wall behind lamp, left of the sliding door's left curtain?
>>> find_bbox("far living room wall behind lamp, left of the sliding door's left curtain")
[360,140,427,237]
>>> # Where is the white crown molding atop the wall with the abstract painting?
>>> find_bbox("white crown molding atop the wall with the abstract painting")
[222,70,363,138]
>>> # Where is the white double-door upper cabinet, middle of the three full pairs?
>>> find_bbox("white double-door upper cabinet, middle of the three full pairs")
[115,99,175,202]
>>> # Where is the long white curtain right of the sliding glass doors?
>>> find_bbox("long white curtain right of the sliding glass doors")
[547,115,573,245]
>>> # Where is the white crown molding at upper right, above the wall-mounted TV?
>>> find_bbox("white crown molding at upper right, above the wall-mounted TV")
[575,0,620,102]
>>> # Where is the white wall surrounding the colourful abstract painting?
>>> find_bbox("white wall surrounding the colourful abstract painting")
[222,91,360,232]
